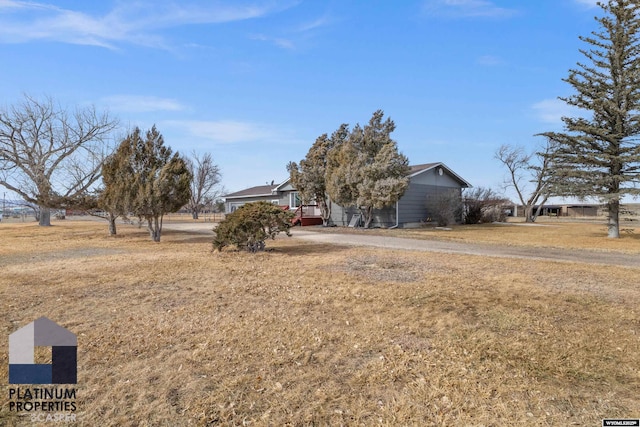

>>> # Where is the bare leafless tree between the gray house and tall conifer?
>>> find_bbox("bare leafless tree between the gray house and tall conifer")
[495,139,556,222]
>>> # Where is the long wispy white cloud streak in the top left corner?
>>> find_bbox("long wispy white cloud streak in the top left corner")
[0,0,287,49]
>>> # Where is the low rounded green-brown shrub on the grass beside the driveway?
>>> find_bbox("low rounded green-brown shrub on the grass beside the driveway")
[213,202,293,252]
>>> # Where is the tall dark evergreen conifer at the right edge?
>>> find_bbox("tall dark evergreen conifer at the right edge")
[543,0,640,238]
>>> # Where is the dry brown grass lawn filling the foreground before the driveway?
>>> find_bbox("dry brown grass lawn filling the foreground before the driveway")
[0,222,640,426]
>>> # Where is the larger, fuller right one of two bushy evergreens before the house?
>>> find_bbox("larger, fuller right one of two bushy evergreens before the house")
[327,110,410,228]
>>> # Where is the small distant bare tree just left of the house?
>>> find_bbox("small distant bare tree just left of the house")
[185,152,223,219]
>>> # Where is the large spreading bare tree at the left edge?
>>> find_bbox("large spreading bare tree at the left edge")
[0,95,117,225]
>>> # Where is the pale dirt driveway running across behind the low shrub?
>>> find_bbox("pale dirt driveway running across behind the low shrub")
[164,223,640,268]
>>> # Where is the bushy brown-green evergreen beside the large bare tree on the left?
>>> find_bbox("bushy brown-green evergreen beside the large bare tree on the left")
[104,126,191,242]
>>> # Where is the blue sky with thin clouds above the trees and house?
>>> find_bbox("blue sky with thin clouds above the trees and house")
[0,0,600,201]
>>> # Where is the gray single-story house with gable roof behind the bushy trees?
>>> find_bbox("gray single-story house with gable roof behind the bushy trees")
[225,163,471,227]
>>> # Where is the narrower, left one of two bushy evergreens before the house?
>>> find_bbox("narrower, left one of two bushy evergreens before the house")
[287,133,334,226]
